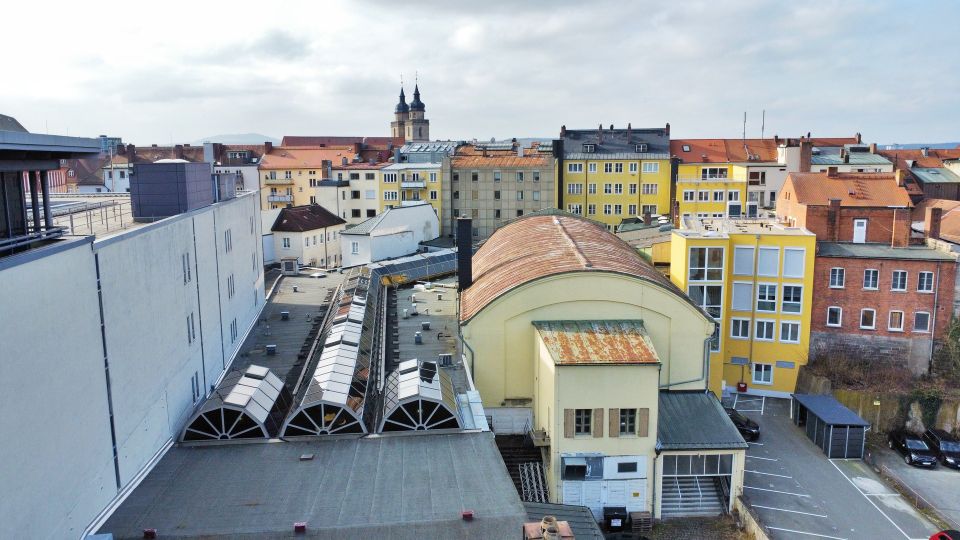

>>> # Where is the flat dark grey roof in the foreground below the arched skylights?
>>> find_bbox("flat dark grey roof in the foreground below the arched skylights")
[99,432,528,539]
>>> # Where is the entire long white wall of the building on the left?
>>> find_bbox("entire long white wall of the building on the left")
[0,193,264,538]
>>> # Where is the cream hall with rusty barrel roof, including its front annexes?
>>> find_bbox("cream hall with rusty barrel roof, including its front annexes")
[458,210,746,519]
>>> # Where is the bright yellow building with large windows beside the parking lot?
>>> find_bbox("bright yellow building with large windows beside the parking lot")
[670,219,816,396]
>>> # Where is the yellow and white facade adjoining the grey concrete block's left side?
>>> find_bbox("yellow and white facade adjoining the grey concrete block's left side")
[380,163,447,222]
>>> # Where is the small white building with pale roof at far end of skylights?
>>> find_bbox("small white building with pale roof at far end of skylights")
[340,201,440,268]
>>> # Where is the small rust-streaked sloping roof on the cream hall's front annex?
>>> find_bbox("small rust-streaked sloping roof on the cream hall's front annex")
[533,320,660,366]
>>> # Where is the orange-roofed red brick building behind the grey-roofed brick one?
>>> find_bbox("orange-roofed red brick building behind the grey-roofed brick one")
[777,172,913,247]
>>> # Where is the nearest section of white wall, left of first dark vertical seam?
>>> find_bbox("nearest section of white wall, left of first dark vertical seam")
[0,242,117,538]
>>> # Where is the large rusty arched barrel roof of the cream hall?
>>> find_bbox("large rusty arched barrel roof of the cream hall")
[460,212,689,322]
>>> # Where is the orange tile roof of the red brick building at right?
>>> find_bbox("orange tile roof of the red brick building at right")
[786,172,913,207]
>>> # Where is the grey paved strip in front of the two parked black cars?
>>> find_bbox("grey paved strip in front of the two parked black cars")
[873,436,960,528]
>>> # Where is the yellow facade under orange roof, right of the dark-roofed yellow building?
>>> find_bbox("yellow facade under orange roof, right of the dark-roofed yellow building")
[676,163,747,218]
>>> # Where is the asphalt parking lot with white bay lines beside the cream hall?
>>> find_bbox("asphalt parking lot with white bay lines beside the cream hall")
[725,396,936,540]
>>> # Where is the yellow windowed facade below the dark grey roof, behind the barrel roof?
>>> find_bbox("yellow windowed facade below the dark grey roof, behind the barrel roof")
[556,155,671,229]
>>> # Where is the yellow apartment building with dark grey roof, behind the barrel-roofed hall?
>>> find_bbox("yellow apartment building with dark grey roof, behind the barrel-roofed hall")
[557,124,673,230]
